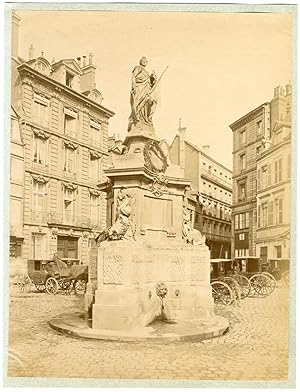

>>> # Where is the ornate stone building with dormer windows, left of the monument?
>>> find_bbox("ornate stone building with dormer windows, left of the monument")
[12,14,113,270]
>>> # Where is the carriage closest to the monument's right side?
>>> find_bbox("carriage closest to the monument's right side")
[210,259,251,306]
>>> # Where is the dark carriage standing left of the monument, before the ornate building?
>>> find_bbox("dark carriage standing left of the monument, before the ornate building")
[17,256,87,295]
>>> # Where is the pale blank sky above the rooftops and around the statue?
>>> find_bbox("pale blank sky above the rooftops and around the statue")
[18,11,292,169]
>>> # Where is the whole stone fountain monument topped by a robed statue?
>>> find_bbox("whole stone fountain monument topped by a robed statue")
[86,57,225,332]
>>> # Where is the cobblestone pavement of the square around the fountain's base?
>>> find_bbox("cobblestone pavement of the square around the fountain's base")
[8,286,288,381]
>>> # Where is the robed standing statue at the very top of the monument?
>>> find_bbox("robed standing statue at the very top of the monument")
[129,65,155,125]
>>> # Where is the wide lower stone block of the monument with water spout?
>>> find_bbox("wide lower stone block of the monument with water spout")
[93,241,213,330]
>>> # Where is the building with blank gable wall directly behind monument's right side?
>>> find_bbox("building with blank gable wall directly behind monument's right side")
[169,127,232,258]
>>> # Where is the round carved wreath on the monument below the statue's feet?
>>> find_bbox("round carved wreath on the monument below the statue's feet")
[144,140,168,173]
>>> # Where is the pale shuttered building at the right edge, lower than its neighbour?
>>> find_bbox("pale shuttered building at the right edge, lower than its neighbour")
[256,107,291,261]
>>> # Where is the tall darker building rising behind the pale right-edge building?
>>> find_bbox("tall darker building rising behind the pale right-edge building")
[230,84,291,258]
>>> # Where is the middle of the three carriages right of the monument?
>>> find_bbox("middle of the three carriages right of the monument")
[233,256,276,297]
